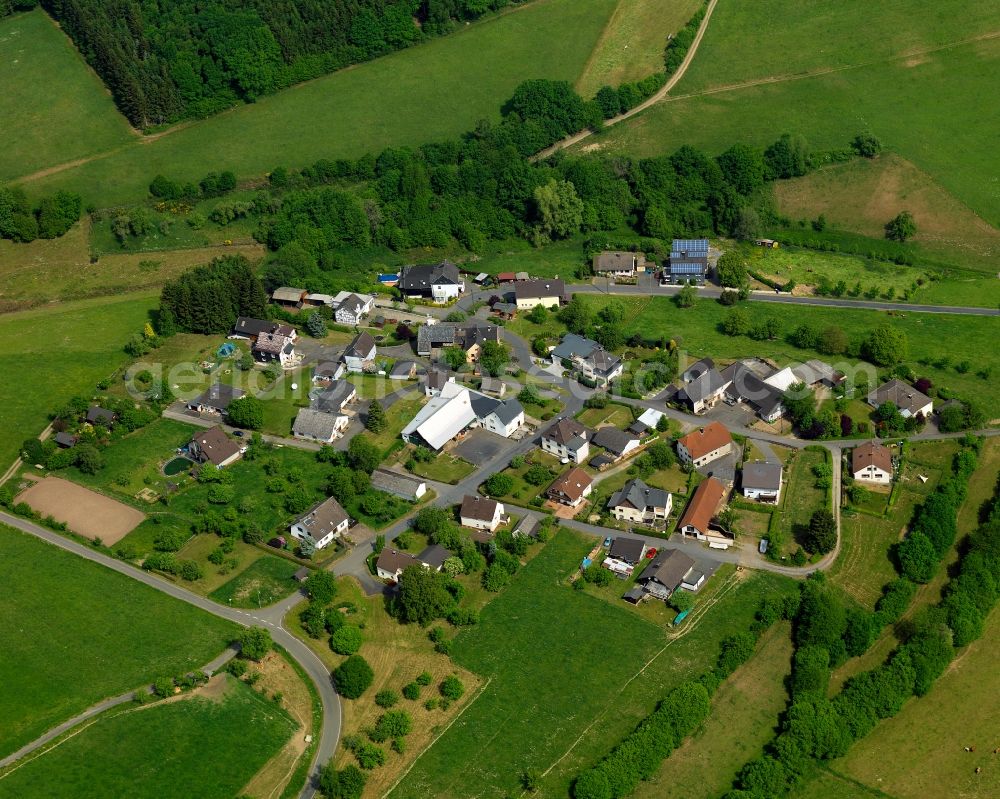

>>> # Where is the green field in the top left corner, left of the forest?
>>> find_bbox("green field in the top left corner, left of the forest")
[0,11,135,181]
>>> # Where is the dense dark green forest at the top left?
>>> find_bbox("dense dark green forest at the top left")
[36,0,520,128]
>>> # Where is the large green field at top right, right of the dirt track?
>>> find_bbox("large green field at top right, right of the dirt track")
[583,0,1000,226]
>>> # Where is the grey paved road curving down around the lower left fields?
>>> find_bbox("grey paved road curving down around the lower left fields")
[0,512,341,799]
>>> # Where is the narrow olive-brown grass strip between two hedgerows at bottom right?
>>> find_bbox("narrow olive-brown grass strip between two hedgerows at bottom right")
[632,622,792,799]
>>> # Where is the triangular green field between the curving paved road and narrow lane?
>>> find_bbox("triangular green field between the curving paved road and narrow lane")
[0,525,236,756]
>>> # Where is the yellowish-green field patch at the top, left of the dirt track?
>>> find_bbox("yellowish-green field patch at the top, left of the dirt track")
[576,0,702,99]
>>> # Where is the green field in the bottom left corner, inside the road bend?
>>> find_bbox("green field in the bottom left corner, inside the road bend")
[0,675,299,799]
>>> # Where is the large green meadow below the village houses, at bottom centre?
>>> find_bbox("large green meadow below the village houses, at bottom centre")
[392,531,788,799]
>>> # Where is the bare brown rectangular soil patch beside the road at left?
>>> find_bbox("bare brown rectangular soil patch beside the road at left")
[16,477,146,546]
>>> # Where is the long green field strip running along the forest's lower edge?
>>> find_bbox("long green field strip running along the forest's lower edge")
[19,0,616,206]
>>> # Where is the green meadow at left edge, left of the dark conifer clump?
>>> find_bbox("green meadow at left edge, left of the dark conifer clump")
[0,295,156,465]
